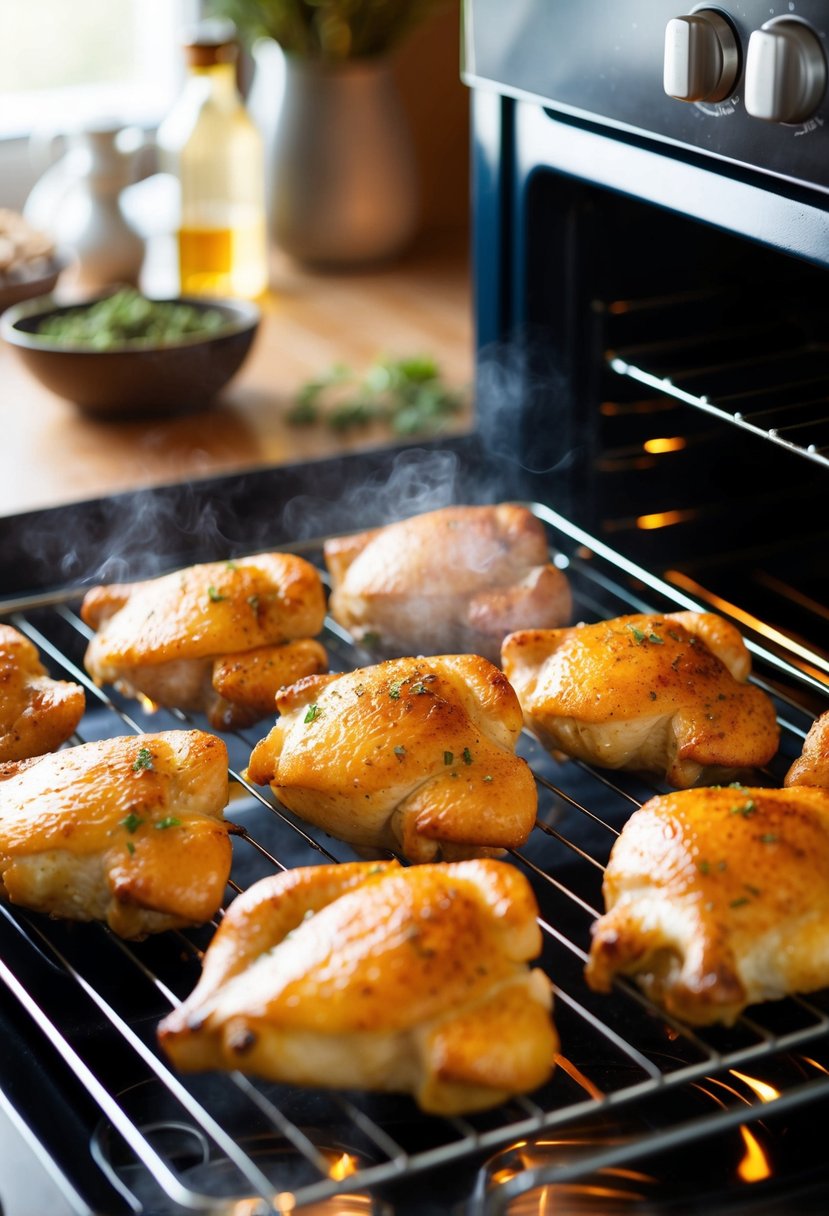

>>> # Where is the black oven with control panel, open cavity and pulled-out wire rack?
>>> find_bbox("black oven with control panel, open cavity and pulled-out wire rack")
[0,0,829,1216]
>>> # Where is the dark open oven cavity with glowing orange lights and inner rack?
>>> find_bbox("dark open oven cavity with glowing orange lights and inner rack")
[478,169,829,695]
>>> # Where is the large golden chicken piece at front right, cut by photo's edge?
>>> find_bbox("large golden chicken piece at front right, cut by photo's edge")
[586,786,829,1025]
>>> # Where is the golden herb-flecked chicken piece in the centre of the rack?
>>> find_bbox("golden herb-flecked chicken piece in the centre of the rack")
[248,654,537,862]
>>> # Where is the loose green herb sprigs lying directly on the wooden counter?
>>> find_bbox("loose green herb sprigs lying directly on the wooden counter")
[287,355,467,435]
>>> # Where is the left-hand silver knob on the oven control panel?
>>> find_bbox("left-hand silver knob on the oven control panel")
[662,9,740,101]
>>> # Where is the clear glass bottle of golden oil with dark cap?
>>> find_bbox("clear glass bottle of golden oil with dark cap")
[158,21,267,299]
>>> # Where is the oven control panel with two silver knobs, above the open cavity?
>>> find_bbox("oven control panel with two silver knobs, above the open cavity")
[463,0,829,193]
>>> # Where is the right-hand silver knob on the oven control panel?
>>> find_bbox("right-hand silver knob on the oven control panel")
[745,17,827,123]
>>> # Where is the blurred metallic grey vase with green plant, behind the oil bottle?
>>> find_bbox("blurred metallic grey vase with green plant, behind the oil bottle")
[213,0,446,266]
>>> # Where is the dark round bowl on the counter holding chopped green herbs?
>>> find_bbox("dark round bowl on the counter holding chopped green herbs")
[0,297,259,418]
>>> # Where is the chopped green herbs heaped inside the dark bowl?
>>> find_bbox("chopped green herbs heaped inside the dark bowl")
[36,287,226,350]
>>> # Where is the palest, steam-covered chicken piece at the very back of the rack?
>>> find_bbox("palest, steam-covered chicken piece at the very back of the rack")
[325,503,570,663]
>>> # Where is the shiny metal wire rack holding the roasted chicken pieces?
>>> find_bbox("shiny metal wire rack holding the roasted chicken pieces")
[0,506,829,1216]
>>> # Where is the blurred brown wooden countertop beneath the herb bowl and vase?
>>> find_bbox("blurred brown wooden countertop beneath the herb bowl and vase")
[0,230,473,514]
